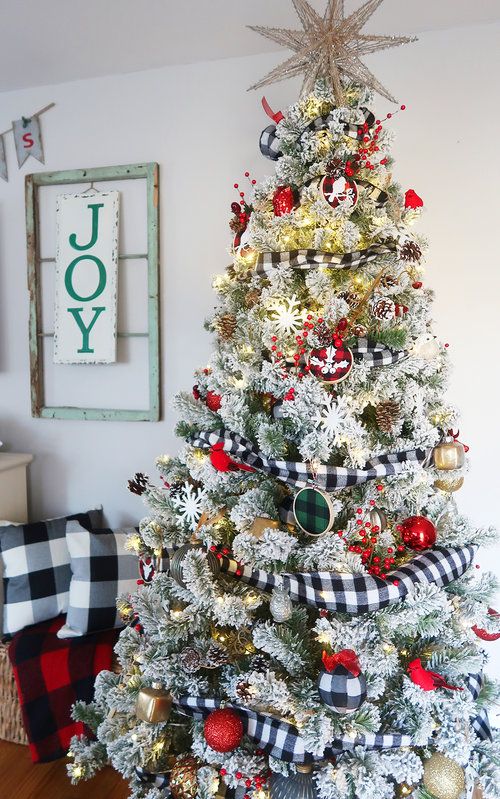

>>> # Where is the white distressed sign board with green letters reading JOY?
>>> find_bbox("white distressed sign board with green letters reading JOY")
[54,191,119,363]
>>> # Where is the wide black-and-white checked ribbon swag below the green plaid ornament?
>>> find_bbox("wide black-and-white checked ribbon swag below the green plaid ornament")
[220,546,475,616]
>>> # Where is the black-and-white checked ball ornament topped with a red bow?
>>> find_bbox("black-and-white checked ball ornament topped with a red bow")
[318,649,366,714]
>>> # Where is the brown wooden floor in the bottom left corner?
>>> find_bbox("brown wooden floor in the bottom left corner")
[0,741,129,799]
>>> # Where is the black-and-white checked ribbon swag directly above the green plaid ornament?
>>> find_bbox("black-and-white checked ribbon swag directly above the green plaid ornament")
[188,429,432,491]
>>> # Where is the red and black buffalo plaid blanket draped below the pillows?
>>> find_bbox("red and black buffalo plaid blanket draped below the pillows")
[9,616,117,763]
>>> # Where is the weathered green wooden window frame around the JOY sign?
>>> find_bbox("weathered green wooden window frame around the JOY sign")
[26,163,161,422]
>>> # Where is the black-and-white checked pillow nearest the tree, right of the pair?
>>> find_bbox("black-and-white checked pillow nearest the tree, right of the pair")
[57,522,139,638]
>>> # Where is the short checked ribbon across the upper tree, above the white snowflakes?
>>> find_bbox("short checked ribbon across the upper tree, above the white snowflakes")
[255,242,397,275]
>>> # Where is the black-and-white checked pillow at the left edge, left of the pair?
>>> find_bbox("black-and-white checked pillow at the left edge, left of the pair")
[0,510,102,635]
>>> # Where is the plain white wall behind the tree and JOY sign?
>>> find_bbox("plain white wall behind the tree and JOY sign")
[0,20,500,664]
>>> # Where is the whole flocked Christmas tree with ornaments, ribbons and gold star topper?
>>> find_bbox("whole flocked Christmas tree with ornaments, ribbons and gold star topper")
[68,0,500,799]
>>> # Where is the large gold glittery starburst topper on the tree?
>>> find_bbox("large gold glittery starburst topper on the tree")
[249,0,415,105]
